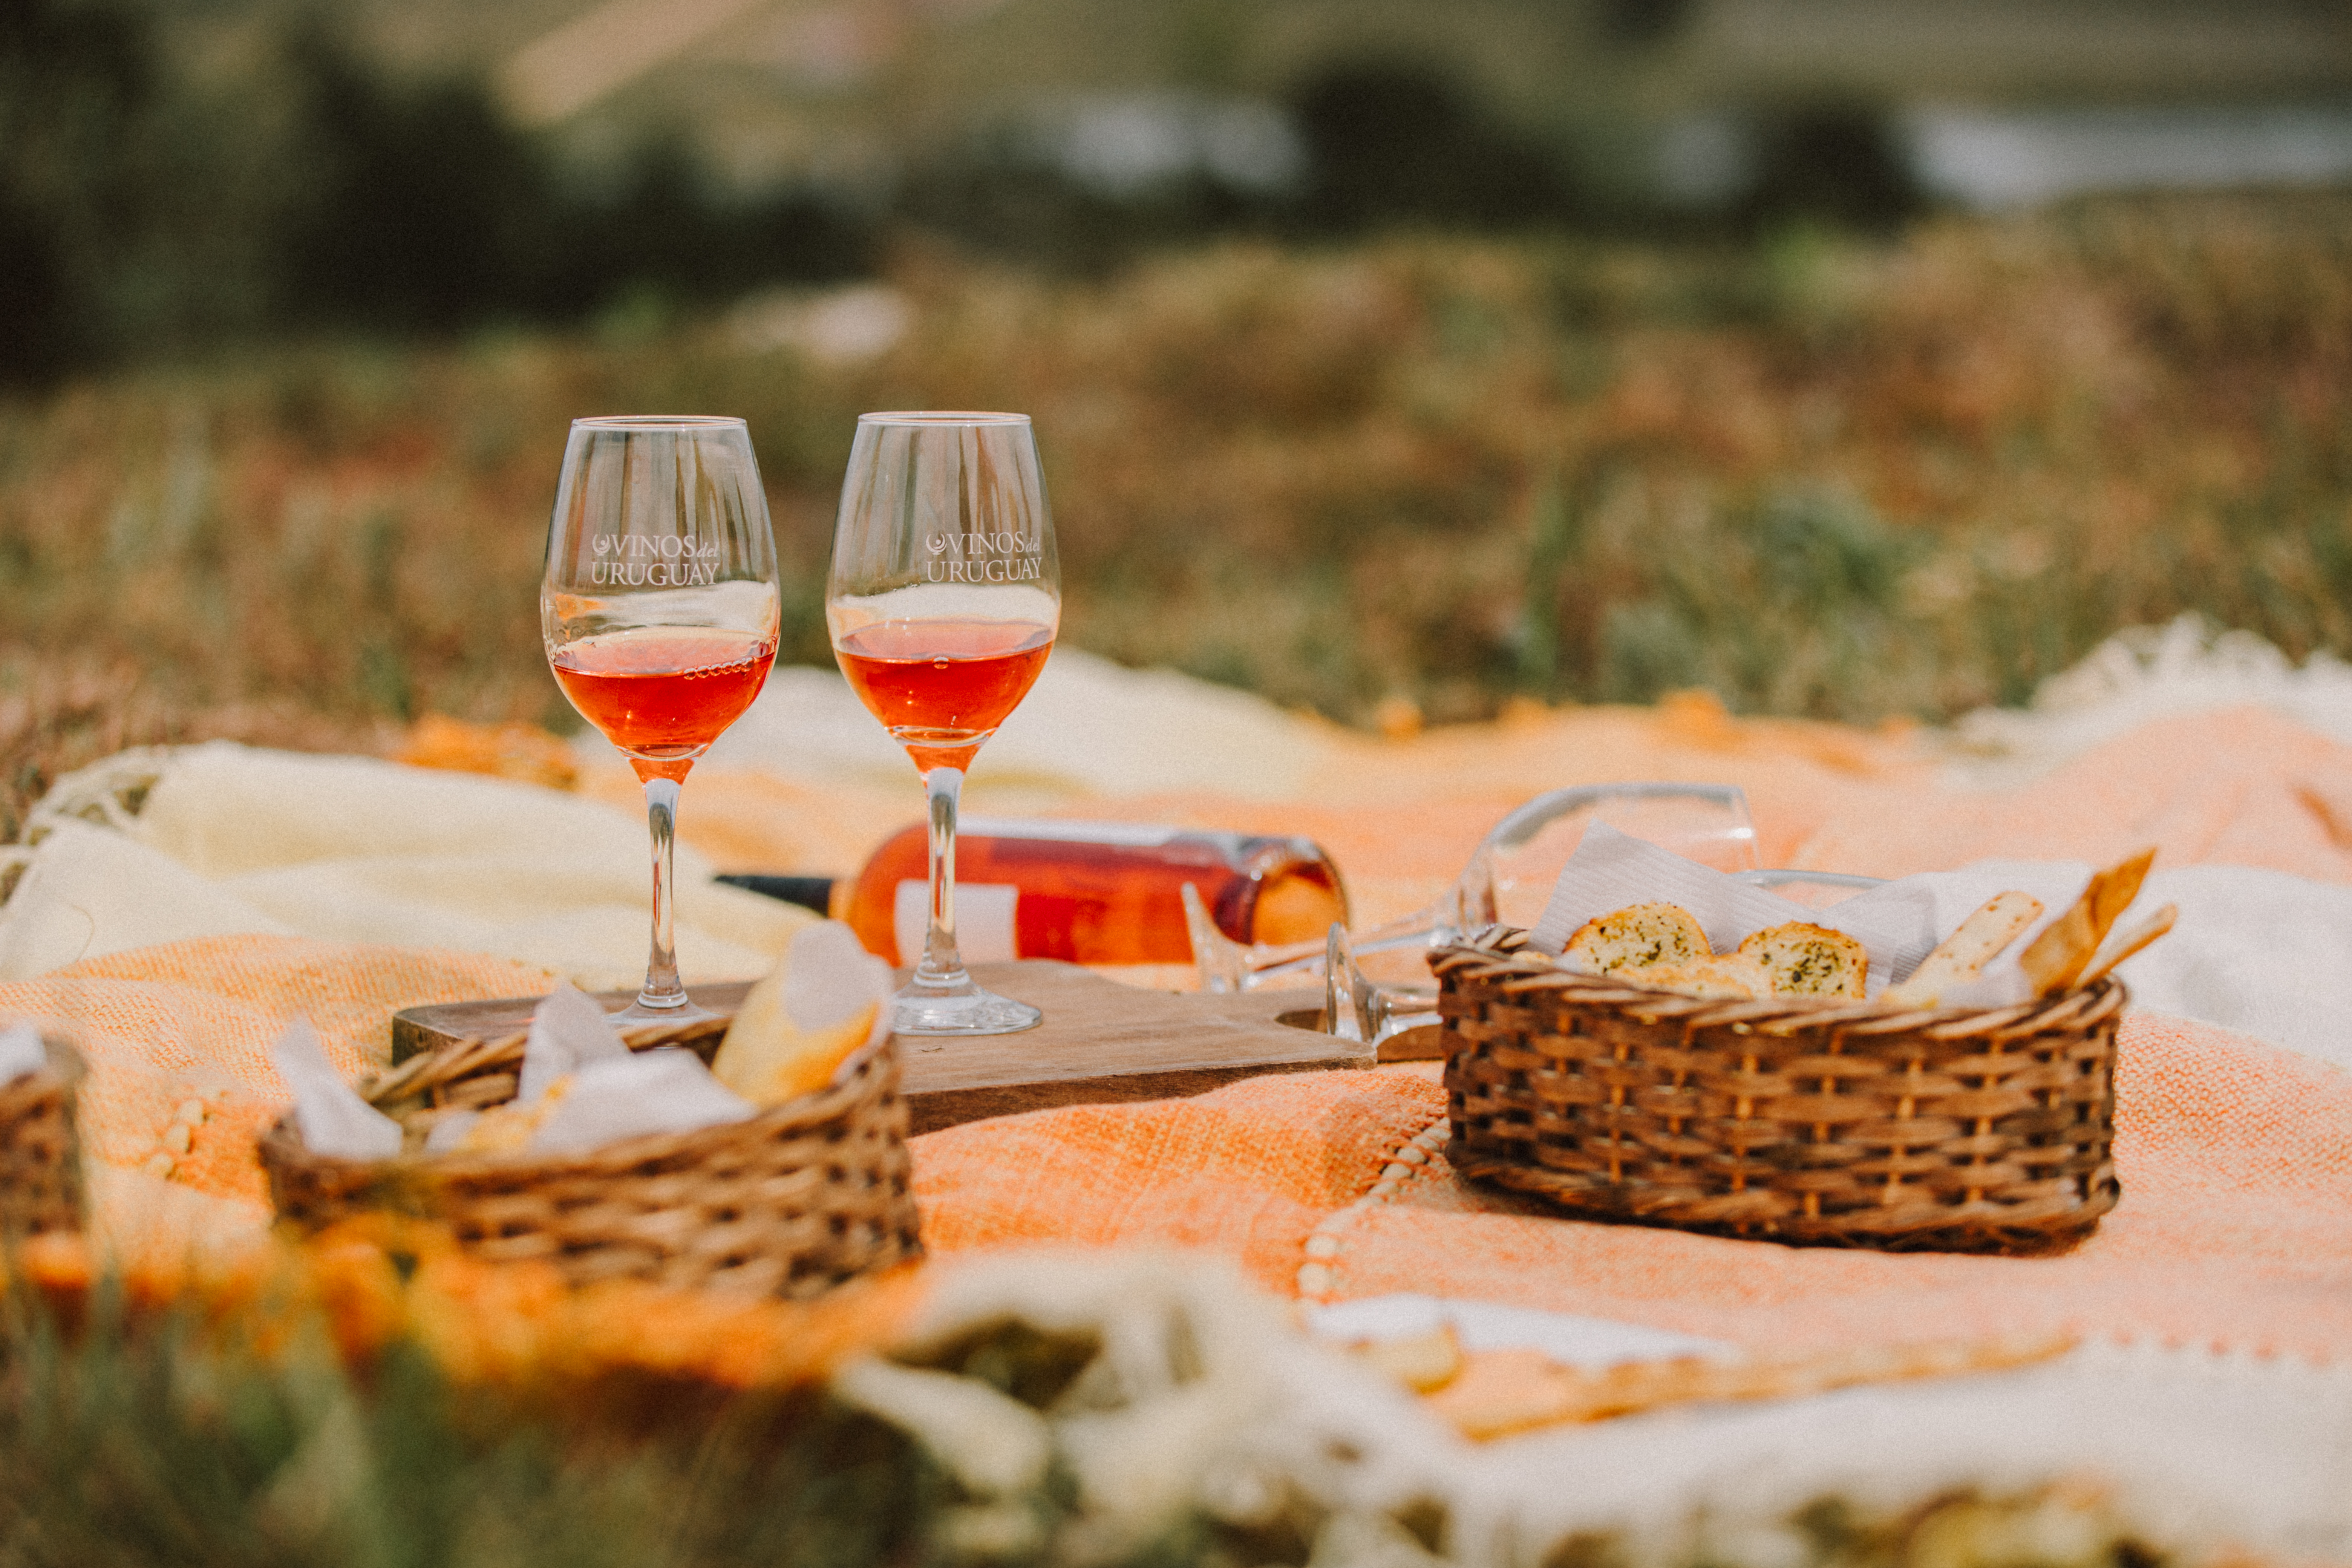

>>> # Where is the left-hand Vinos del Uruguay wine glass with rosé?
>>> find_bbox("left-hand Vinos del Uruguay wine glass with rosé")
[539,416,781,1023]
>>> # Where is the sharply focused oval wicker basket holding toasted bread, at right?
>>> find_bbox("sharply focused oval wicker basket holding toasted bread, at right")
[1430,931,2124,1253]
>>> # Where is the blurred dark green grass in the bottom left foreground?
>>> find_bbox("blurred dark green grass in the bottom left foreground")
[0,1309,943,1568]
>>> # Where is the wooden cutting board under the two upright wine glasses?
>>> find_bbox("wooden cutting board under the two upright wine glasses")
[393,959,1411,1133]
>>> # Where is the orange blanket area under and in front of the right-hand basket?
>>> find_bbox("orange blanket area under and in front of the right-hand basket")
[915,1015,2352,1361]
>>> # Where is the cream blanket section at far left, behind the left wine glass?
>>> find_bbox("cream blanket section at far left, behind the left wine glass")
[0,741,814,990]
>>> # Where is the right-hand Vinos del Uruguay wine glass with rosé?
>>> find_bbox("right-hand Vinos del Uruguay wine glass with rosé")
[825,414,1061,1034]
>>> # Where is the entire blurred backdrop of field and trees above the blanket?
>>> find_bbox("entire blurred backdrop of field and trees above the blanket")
[0,0,2352,818]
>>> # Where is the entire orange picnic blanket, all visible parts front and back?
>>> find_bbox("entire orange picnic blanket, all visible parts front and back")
[0,707,2352,1357]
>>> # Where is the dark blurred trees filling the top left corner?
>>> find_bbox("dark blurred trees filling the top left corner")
[0,0,873,383]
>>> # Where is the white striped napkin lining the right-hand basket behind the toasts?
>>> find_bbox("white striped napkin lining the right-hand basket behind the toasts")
[1529,823,2091,1006]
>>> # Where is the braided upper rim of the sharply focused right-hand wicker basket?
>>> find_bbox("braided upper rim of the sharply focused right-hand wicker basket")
[1430,926,2131,1037]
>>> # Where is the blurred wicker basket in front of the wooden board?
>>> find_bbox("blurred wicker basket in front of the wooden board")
[261,1025,922,1298]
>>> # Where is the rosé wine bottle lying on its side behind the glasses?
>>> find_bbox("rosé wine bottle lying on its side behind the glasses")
[724,816,1348,964]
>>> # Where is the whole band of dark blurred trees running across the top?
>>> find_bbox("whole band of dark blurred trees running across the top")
[0,0,1917,383]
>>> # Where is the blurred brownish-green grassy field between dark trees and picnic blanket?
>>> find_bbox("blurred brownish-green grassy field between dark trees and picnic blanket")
[0,195,2352,827]
